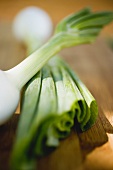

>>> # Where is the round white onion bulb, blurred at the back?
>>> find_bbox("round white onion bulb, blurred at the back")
[12,6,53,54]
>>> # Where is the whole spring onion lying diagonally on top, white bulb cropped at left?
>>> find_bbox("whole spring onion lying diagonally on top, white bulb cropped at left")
[0,9,113,124]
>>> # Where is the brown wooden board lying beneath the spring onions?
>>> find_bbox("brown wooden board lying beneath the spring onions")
[0,22,113,170]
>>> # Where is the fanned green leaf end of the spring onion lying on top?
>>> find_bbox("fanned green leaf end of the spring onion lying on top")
[55,8,113,47]
